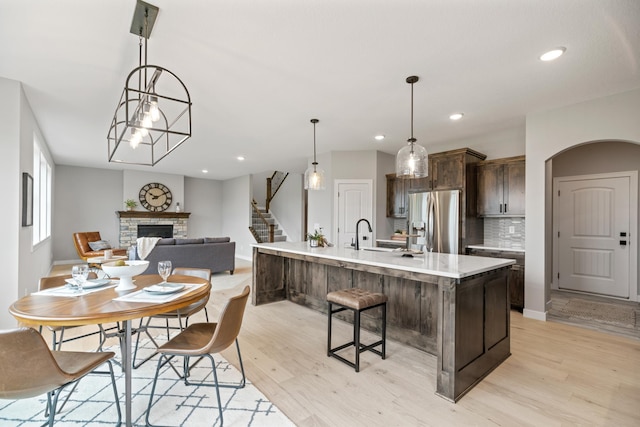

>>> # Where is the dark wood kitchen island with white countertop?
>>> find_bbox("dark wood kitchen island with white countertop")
[251,242,515,402]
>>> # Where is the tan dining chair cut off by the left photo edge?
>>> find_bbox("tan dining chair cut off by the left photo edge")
[0,328,122,426]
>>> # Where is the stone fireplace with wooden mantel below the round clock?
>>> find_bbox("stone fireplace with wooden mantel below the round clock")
[116,211,191,248]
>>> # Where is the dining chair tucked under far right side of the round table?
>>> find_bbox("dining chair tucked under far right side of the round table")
[133,267,211,369]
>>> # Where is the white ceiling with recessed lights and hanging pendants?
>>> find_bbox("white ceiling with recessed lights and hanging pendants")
[0,0,640,179]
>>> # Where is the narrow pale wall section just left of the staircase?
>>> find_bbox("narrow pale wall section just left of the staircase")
[221,175,255,260]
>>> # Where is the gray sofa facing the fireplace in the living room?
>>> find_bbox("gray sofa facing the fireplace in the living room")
[142,237,236,274]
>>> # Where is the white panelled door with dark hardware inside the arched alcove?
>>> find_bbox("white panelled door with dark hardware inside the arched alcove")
[554,176,636,298]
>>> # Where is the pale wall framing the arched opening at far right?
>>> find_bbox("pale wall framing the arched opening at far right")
[524,90,640,319]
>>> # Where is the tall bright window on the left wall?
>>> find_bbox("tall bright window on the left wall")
[33,135,51,246]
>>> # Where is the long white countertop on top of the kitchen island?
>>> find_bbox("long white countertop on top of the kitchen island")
[252,242,515,279]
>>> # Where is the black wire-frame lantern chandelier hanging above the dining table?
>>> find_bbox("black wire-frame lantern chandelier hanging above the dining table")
[107,0,191,166]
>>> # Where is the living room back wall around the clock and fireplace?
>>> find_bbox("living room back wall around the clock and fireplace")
[52,165,232,262]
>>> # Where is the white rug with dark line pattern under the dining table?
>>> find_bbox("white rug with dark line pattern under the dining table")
[0,341,294,427]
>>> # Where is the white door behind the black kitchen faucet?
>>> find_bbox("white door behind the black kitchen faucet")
[334,179,374,248]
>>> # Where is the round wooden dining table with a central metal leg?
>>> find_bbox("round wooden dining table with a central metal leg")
[9,274,211,426]
